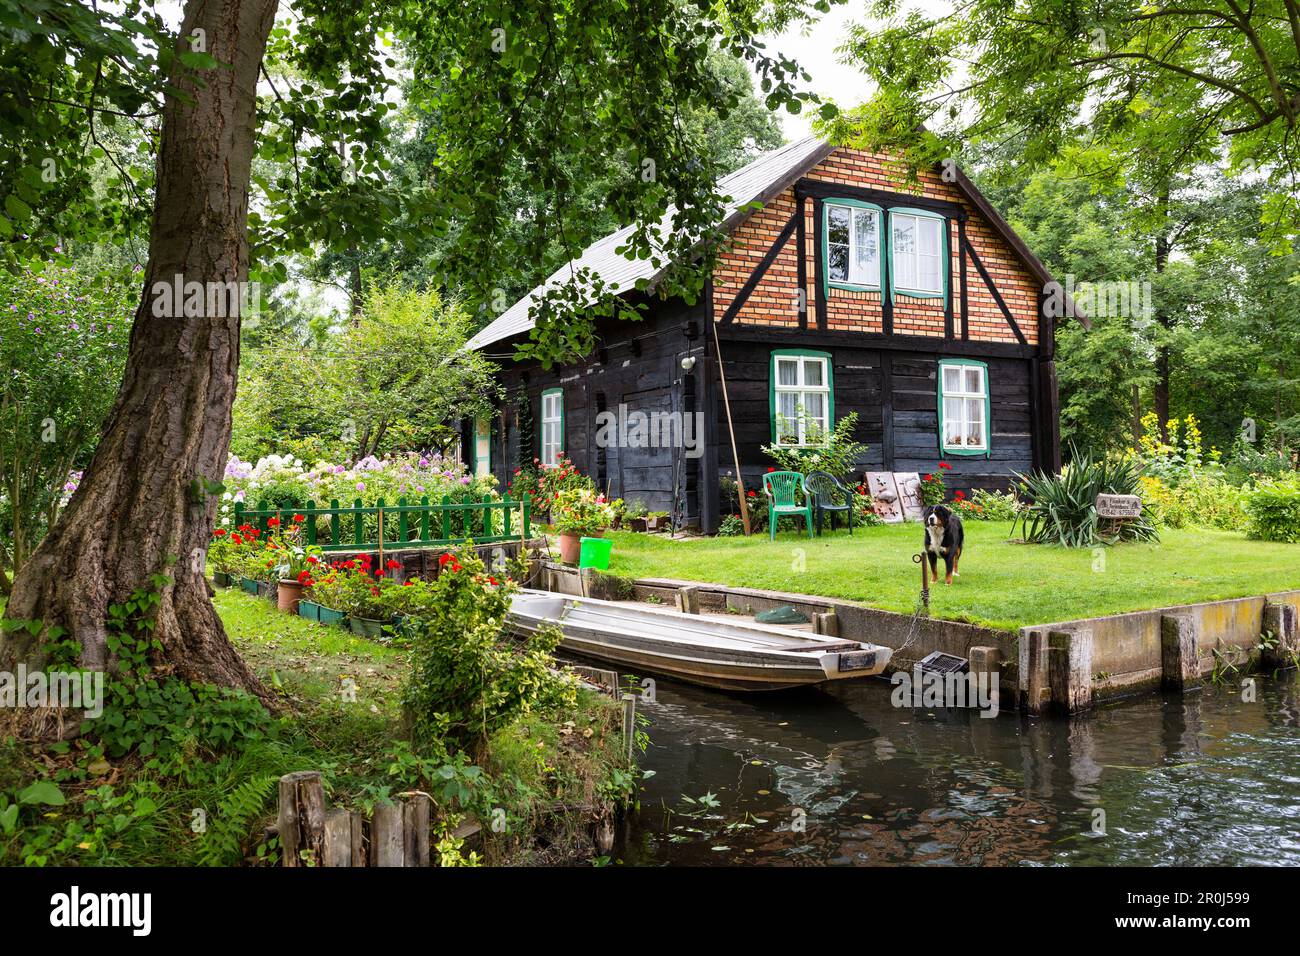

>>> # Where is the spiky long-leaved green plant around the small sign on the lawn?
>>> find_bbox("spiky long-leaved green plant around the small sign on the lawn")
[1011,455,1160,548]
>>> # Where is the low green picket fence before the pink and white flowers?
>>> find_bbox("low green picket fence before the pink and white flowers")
[234,494,532,551]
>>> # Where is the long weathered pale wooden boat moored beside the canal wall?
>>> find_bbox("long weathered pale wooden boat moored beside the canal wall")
[507,589,893,691]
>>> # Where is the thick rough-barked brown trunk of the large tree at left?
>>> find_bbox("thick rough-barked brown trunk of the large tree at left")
[0,0,277,697]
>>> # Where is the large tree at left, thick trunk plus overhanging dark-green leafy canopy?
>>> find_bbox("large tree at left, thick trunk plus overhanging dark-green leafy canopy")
[0,0,821,712]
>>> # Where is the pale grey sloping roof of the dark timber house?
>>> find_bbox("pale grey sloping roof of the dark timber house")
[467,137,831,349]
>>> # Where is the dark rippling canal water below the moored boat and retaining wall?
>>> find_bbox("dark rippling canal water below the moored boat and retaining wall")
[611,672,1300,866]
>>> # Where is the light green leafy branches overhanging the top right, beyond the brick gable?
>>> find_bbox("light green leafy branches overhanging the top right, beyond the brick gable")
[826,0,1300,248]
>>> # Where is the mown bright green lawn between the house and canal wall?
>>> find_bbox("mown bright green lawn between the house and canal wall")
[610,522,1300,630]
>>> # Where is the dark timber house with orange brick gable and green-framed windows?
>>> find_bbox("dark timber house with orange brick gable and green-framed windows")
[465,139,1087,531]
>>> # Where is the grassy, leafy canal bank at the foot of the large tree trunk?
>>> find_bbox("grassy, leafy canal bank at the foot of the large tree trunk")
[0,591,636,865]
